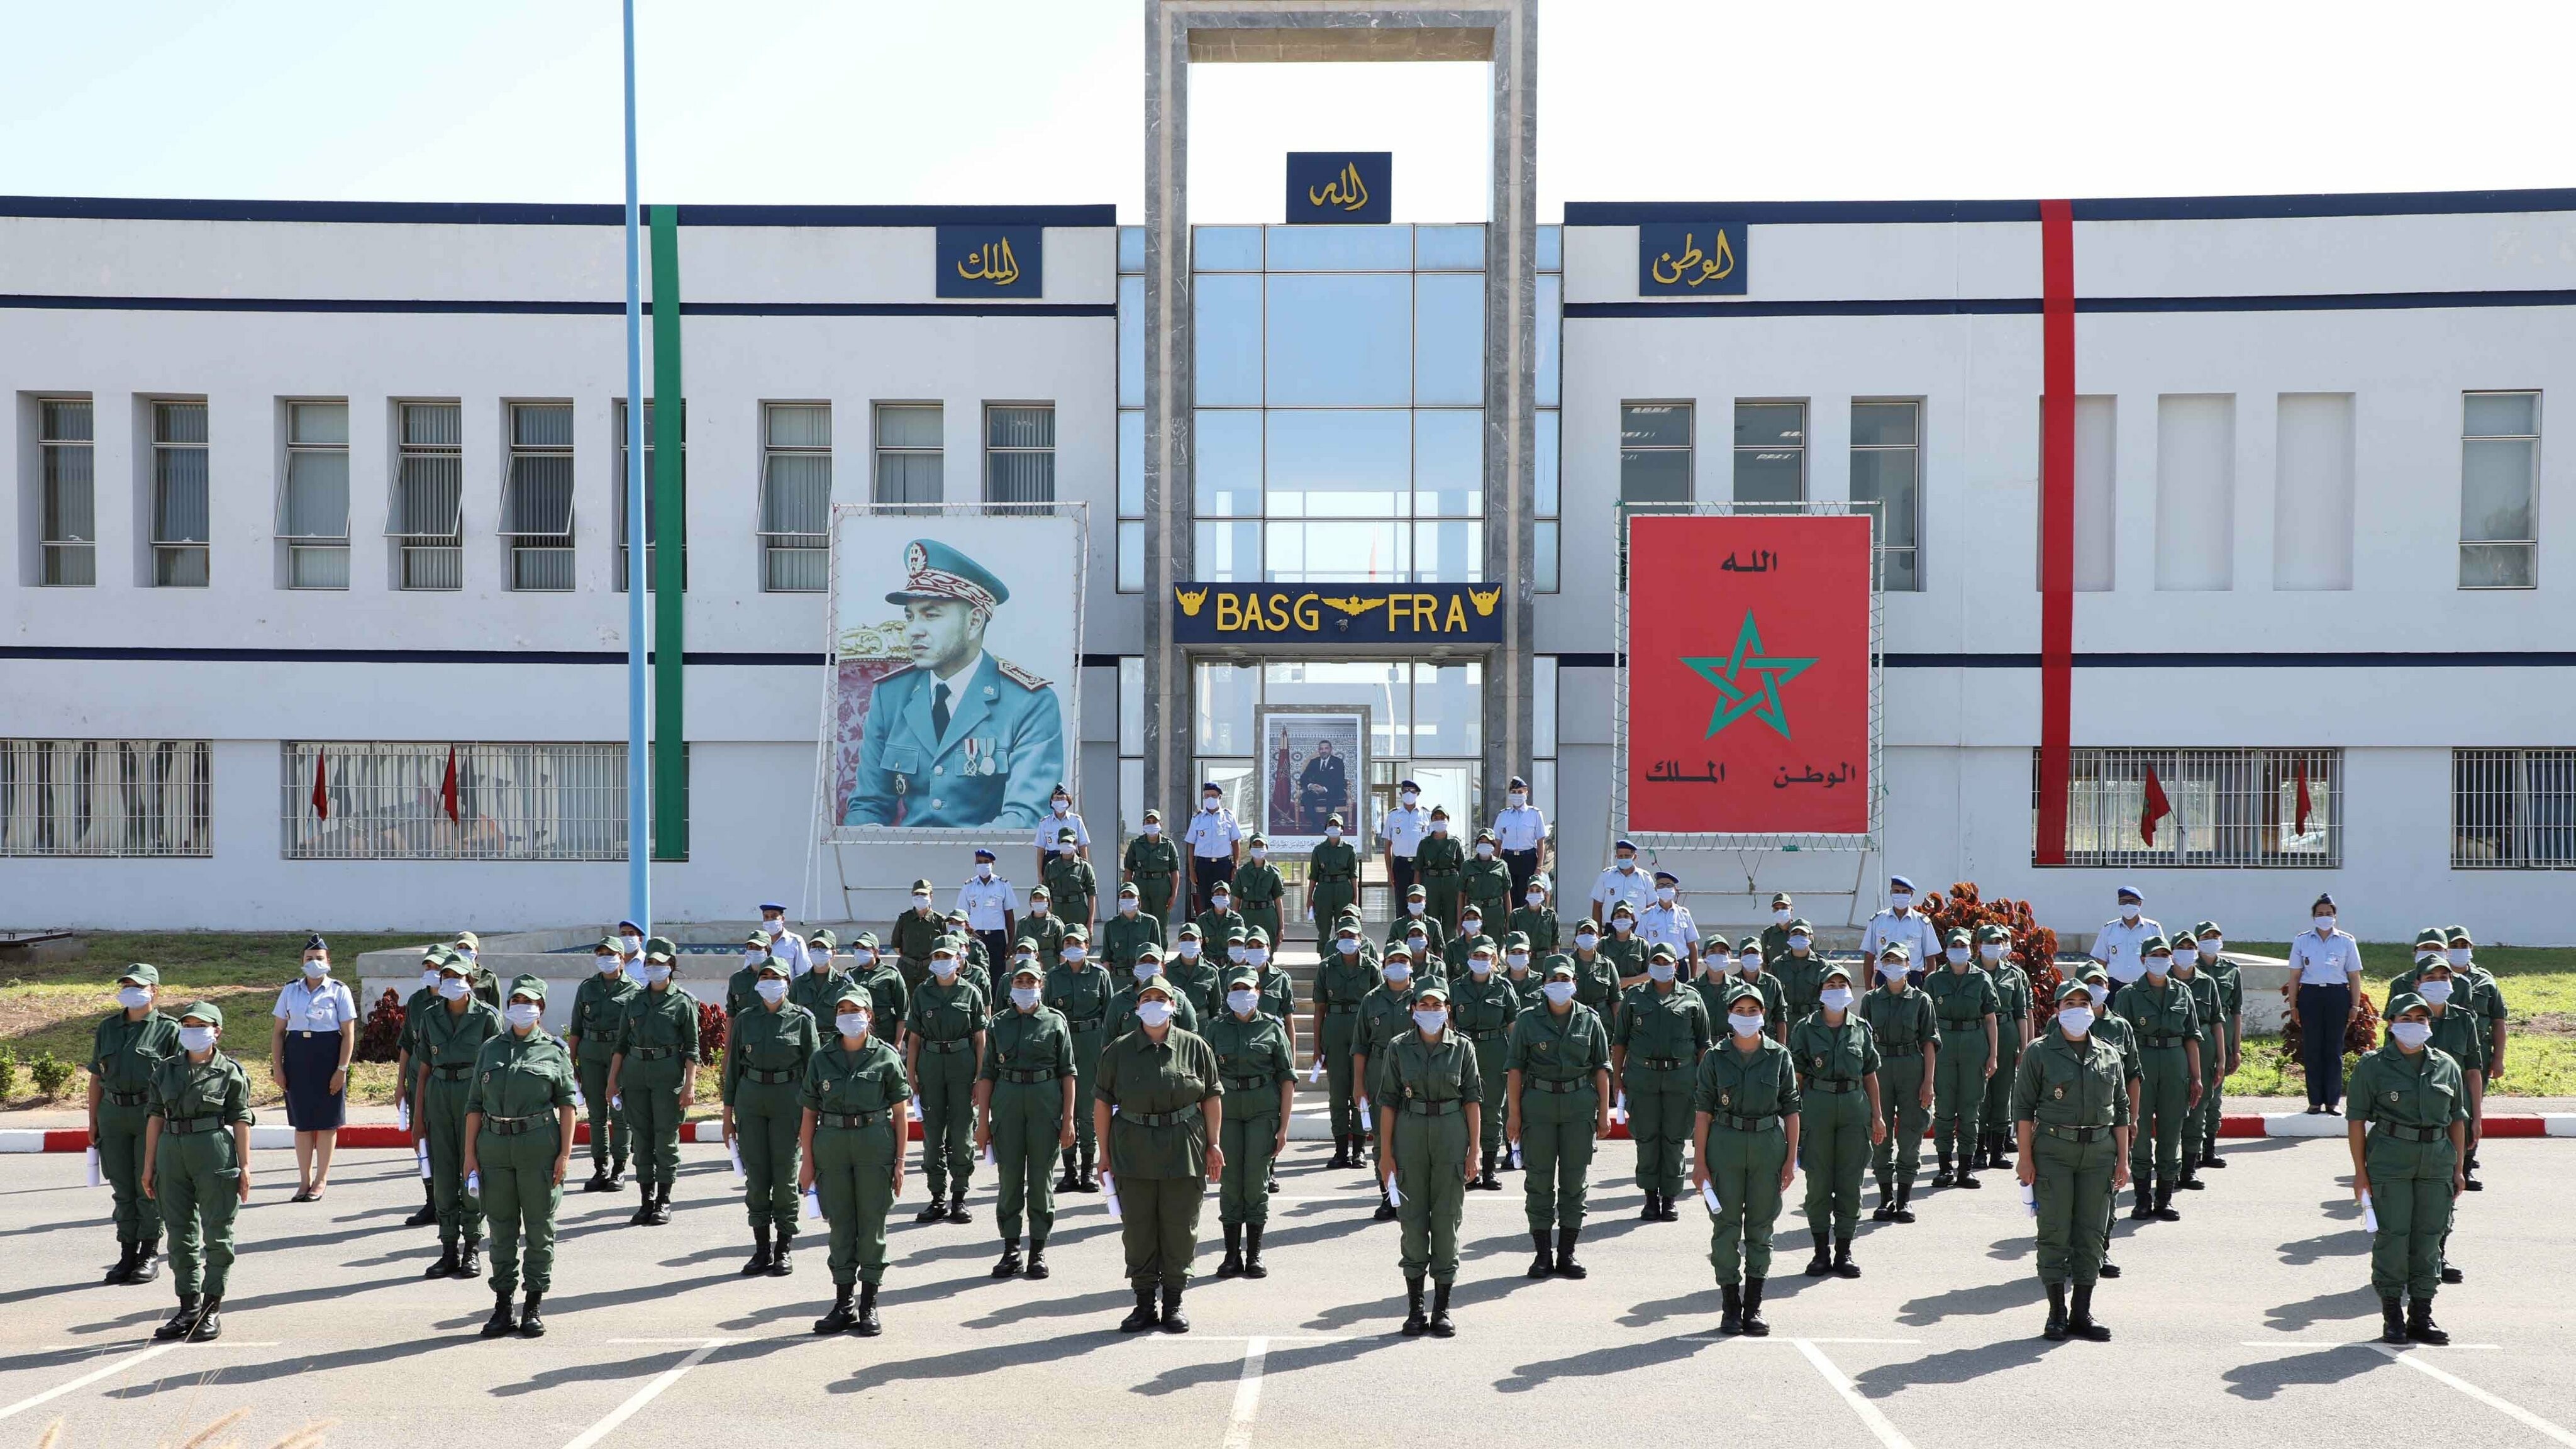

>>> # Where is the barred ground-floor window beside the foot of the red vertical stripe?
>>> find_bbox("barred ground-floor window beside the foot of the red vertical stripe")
[2030,748,2344,869]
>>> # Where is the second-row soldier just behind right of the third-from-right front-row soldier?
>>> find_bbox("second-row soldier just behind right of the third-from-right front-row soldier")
[1788,964,1888,1279]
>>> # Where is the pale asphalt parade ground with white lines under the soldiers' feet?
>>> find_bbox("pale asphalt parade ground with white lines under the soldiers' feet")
[0,1140,2576,1449]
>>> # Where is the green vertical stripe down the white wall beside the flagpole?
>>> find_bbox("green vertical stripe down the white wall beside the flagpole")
[652,206,688,861]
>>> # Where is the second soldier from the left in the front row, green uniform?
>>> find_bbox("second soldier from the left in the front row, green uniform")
[466,977,584,1338]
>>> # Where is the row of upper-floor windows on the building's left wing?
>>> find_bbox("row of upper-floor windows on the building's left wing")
[33,397,1056,593]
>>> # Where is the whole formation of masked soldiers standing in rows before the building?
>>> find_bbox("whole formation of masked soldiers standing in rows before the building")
[92,809,2501,1343]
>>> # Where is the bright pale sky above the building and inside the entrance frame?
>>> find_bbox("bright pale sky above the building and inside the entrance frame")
[0,0,2576,222]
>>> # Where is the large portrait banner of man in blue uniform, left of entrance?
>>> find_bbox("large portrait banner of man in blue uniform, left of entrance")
[827,508,1084,840]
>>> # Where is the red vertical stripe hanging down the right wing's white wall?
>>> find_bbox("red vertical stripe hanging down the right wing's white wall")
[2035,201,2076,866]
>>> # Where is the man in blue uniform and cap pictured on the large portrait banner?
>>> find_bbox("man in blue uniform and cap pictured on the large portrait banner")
[842,539,1064,830]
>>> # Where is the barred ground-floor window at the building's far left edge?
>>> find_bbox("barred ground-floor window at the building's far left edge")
[0,740,214,856]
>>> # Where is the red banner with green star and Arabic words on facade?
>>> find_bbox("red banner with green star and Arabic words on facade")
[1623,513,1875,835]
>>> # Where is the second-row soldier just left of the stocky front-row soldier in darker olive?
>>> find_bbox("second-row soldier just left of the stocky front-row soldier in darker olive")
[974,957,1077,1279]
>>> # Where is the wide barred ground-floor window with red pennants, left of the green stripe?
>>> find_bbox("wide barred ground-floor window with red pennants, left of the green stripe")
[280,740,626,861]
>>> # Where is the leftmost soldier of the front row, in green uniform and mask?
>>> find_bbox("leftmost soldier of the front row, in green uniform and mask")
[142,1001,258,1343]
